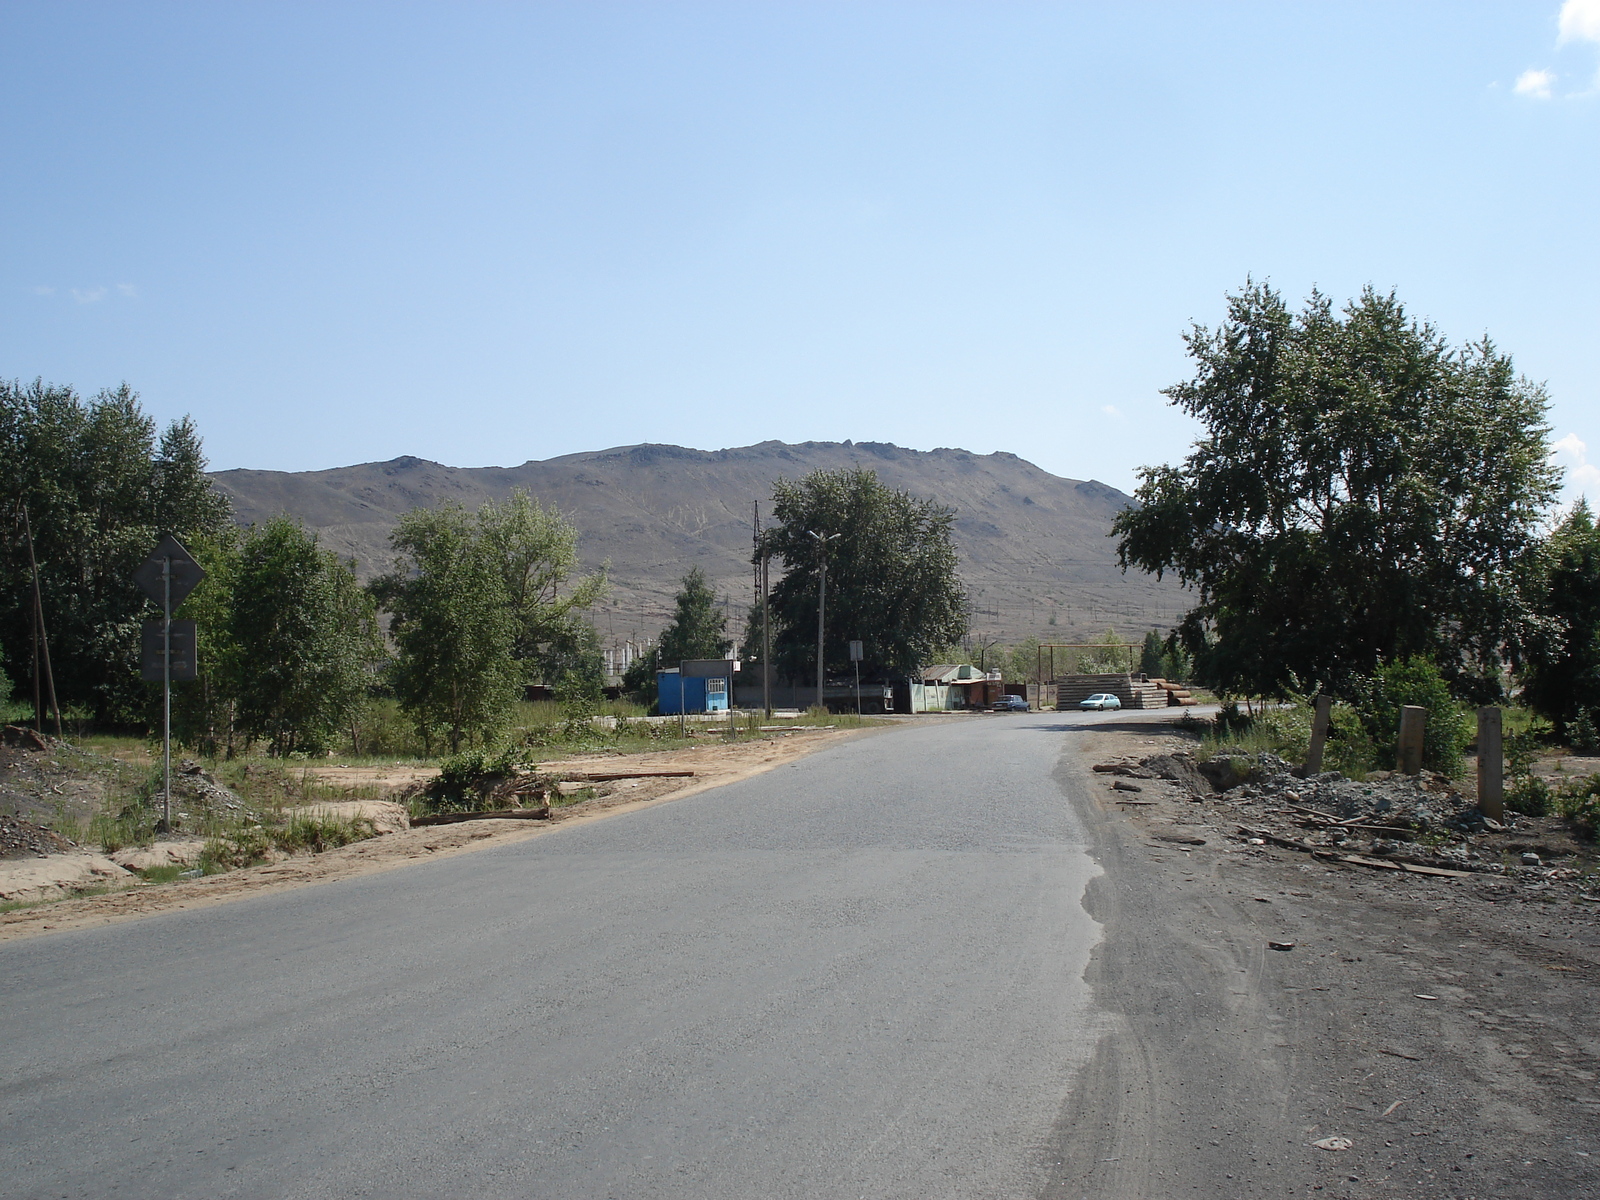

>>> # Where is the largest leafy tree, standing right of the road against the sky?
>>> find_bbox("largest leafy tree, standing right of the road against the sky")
[1114,283,1557,699]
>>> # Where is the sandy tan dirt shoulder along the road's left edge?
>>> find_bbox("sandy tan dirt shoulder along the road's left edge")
[0,726,893,941]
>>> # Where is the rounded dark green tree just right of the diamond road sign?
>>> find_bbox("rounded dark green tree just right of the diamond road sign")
[229,517,382,755]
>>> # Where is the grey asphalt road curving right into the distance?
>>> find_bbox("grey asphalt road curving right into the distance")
[0,714,1138,1200]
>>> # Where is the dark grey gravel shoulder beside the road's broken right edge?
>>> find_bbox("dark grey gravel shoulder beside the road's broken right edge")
[1048,722,1600,1198]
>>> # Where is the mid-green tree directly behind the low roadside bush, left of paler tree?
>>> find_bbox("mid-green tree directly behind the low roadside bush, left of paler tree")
[371,504,525,754]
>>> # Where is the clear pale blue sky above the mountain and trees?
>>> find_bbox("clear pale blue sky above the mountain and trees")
[0,0,1600,496]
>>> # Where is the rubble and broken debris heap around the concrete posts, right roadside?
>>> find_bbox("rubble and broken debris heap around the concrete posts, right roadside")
[1094,747,1600,894]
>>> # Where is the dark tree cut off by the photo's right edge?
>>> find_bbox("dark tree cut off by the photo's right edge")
[1522,501,1600,738]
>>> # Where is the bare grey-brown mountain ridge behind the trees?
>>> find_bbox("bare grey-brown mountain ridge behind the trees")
[211,442,1184,643]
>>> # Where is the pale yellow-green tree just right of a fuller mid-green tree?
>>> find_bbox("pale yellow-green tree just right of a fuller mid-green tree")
[477,488,606,685]
